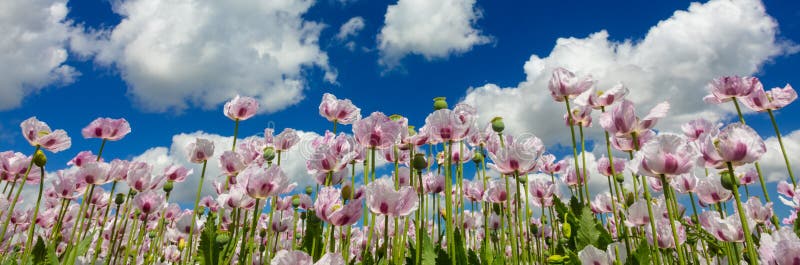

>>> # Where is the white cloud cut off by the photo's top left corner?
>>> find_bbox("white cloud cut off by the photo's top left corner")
[0,0,79,110]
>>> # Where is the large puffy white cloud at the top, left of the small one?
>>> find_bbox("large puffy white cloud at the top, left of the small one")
[90,0,336,112]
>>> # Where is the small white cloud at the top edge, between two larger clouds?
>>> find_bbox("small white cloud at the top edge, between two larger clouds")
[378,0,490,67]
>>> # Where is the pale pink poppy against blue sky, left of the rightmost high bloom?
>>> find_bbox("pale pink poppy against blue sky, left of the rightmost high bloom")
[703,76,764,104]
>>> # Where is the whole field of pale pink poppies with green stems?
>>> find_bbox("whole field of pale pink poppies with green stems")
[0,68,800,264]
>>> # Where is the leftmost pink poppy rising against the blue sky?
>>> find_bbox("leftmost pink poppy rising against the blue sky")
[20,117,72,153]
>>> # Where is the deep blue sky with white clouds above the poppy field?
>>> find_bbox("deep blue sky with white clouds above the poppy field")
[0,0,800,214]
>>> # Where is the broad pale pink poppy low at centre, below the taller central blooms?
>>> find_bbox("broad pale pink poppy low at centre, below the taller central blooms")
[366,178,419,217]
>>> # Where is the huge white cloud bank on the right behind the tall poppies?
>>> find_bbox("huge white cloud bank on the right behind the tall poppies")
[464,0,796,145]
